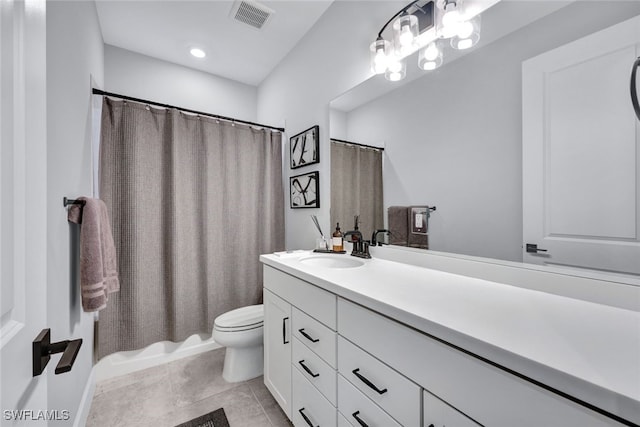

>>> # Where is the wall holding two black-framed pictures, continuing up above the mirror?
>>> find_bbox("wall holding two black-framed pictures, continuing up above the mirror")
[258,1,398,249]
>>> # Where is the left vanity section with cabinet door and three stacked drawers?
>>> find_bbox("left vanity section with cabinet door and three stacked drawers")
[264,266,337,427]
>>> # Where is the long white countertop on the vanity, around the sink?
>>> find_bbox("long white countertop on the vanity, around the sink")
[260,252,640,424]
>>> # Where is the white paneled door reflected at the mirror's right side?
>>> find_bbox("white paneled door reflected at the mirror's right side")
[522,17,640,274]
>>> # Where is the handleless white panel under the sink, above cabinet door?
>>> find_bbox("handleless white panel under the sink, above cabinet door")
[263,265,337,331]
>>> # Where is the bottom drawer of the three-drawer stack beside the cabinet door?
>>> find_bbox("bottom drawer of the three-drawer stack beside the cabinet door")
[291,369,337,427]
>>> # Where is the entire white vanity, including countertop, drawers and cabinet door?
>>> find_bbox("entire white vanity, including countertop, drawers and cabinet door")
[261,255,640,427]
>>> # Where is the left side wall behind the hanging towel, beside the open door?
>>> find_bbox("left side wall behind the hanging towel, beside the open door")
[43,1,104,425]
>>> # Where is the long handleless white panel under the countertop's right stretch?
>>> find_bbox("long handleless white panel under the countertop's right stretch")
[338,298,622,427]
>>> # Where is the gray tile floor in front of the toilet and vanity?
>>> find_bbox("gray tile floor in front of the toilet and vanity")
[87,348,292,427]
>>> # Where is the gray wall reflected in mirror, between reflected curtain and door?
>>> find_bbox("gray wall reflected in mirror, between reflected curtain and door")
[347,1,640,261]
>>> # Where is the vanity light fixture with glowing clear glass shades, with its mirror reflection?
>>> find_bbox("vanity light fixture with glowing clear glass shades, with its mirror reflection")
[369,0,480,81]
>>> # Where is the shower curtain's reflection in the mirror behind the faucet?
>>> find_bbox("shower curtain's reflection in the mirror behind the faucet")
[330,140,384,240]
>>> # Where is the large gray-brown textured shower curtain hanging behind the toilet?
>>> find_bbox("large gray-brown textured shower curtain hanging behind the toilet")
[97,97,284,358]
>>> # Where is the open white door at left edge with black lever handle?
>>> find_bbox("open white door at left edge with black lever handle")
[0,0,48,426]
